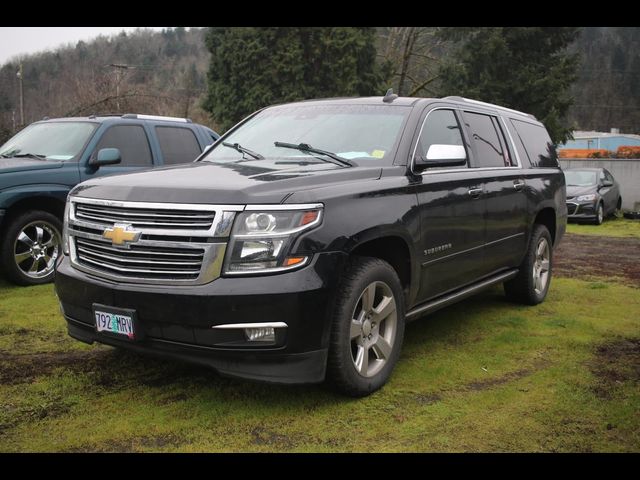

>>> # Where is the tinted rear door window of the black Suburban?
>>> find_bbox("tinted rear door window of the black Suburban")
[464,112,511,167]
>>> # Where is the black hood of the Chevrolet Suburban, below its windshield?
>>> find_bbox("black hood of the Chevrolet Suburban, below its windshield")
[71,160,382,205]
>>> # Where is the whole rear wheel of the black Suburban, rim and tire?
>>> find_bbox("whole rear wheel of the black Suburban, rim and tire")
[504,224,553,305]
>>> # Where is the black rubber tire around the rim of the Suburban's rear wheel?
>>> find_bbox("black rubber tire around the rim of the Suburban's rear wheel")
[504,224,553,305]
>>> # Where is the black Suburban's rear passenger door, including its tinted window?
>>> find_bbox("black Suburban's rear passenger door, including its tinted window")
[463,111,527,276]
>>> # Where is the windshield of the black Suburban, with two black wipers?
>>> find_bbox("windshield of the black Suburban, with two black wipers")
[203,105,410,165]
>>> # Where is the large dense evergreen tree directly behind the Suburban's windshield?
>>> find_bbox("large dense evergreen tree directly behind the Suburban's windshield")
[203,27,384,130]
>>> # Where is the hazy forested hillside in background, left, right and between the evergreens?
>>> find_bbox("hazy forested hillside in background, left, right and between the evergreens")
[0,27,640,141]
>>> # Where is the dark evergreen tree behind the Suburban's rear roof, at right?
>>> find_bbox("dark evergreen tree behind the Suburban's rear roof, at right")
[440,27,580,142]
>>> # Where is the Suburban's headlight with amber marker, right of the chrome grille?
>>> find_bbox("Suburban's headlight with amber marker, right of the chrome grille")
[224,205,322,275]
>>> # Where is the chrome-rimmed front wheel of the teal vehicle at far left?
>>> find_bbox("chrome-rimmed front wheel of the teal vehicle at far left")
[0,210,62,285]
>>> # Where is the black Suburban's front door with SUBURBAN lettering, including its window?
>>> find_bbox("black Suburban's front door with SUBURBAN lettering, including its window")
[412,108,485,302]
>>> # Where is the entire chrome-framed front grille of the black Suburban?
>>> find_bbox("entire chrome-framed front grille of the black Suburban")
[68,197,244,285]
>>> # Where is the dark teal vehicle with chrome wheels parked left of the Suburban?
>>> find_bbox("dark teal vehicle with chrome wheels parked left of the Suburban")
[0,114,219,285]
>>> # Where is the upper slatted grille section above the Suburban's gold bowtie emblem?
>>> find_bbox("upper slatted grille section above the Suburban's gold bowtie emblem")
[75,203,215,230]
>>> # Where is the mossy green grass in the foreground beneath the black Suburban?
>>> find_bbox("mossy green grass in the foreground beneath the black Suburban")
[0,278,640,452]
